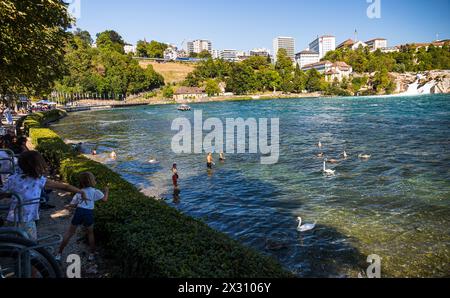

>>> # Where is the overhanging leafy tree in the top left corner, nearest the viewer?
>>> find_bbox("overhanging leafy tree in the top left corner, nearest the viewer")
[0,0,72,101]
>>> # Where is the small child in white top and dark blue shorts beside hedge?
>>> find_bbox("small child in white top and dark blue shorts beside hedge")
[56,173,109,261]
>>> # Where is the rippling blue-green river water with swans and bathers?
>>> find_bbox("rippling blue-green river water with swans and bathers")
[54,95,450,277]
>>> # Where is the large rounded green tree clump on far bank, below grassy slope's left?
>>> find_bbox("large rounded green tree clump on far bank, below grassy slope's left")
[55,31,164,99]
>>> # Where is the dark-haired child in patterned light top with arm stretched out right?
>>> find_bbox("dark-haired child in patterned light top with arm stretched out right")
[0,151,87,241]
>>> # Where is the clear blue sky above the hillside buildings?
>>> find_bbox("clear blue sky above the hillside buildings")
[77,0,450,50]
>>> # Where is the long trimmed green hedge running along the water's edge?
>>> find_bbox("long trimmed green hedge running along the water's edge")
[22,111,293,278]
